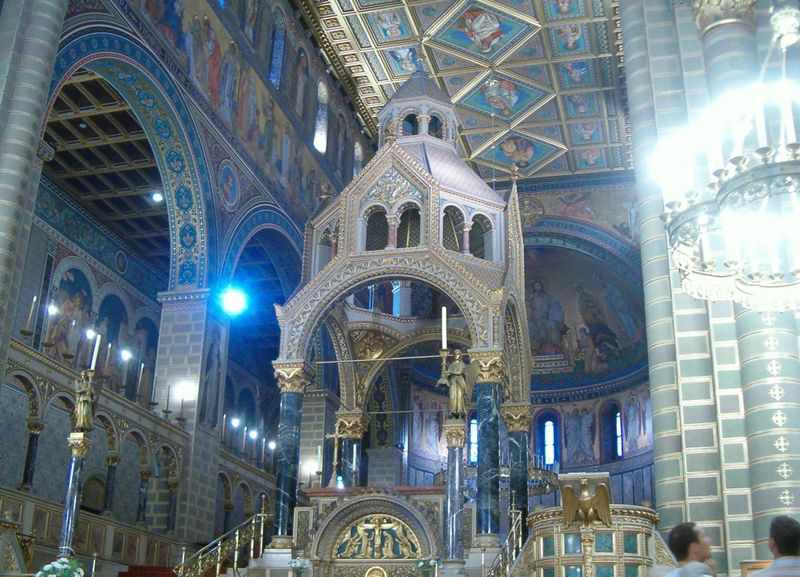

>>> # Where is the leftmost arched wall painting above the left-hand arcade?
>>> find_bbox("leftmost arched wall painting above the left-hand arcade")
[44,268,92,361]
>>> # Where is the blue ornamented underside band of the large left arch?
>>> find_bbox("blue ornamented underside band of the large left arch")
[48,29,217,290]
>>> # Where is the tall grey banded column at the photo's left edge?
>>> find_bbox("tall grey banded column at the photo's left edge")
[0,0,69,367]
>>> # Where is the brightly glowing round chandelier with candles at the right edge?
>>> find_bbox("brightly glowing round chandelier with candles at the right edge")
[650,3,800,311]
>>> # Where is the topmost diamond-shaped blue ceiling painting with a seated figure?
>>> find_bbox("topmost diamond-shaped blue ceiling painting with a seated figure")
[435,2,533,60]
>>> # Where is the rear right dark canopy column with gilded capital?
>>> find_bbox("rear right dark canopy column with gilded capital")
[501,403,531,540]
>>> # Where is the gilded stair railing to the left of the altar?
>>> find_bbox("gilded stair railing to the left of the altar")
[173,513,271,577]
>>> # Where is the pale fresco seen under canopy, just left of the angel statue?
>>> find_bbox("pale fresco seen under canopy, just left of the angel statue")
[410,386,447,461]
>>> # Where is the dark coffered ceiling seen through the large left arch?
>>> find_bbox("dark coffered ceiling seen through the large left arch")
[44,69,170,275]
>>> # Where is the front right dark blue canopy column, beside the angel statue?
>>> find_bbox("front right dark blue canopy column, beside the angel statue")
[470,351,504,547]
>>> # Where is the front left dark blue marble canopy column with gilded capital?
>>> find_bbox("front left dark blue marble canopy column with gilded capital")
[272,362,310,549]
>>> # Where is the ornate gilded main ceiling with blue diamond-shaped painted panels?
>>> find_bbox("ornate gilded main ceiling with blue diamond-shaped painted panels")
[302,0,629,180]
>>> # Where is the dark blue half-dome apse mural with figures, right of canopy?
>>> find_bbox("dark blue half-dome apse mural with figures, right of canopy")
[525,247,645,385]
